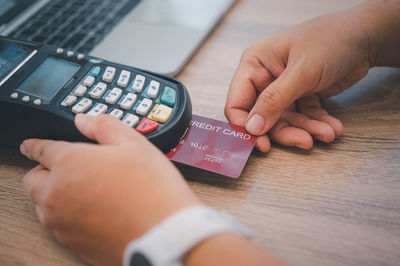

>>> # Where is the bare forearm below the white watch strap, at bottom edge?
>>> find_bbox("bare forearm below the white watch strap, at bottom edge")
[185,234,283,266]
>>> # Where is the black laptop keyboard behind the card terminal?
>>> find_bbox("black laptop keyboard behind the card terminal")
[10,0,140,53]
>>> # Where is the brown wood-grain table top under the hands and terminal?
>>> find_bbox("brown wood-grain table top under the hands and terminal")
[0,0,400,265]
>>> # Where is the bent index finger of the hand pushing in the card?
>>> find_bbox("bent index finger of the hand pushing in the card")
[225,53,274,126]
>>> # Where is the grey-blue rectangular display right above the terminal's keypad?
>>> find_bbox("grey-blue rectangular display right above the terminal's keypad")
[17,57,81,101]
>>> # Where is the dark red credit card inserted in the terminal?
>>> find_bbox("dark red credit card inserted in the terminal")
[167,115,257,178]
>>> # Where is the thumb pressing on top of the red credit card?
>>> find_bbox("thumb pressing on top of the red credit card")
[246,68,309,135]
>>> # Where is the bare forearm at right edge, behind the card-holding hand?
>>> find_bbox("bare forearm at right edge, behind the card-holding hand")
[355,0,400,67]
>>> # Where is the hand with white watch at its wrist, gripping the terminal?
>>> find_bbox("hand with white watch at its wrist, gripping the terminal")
[21,115,200,265]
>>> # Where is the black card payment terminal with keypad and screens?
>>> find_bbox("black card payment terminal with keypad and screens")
[0,36,192,152]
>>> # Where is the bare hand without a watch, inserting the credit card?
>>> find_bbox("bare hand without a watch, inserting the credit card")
[225,6,370,152]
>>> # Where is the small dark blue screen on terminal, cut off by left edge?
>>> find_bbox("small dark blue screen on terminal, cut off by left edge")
[0,42,32,81]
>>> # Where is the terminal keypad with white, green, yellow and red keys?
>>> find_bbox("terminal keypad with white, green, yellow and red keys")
[61,65,177,134]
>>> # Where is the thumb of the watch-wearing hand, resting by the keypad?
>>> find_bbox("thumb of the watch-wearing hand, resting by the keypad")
[75,114,142,145]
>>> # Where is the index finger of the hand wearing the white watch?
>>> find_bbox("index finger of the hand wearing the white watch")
[20,139,68,169]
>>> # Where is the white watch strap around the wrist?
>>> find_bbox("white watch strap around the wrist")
[124,206,249,266]
